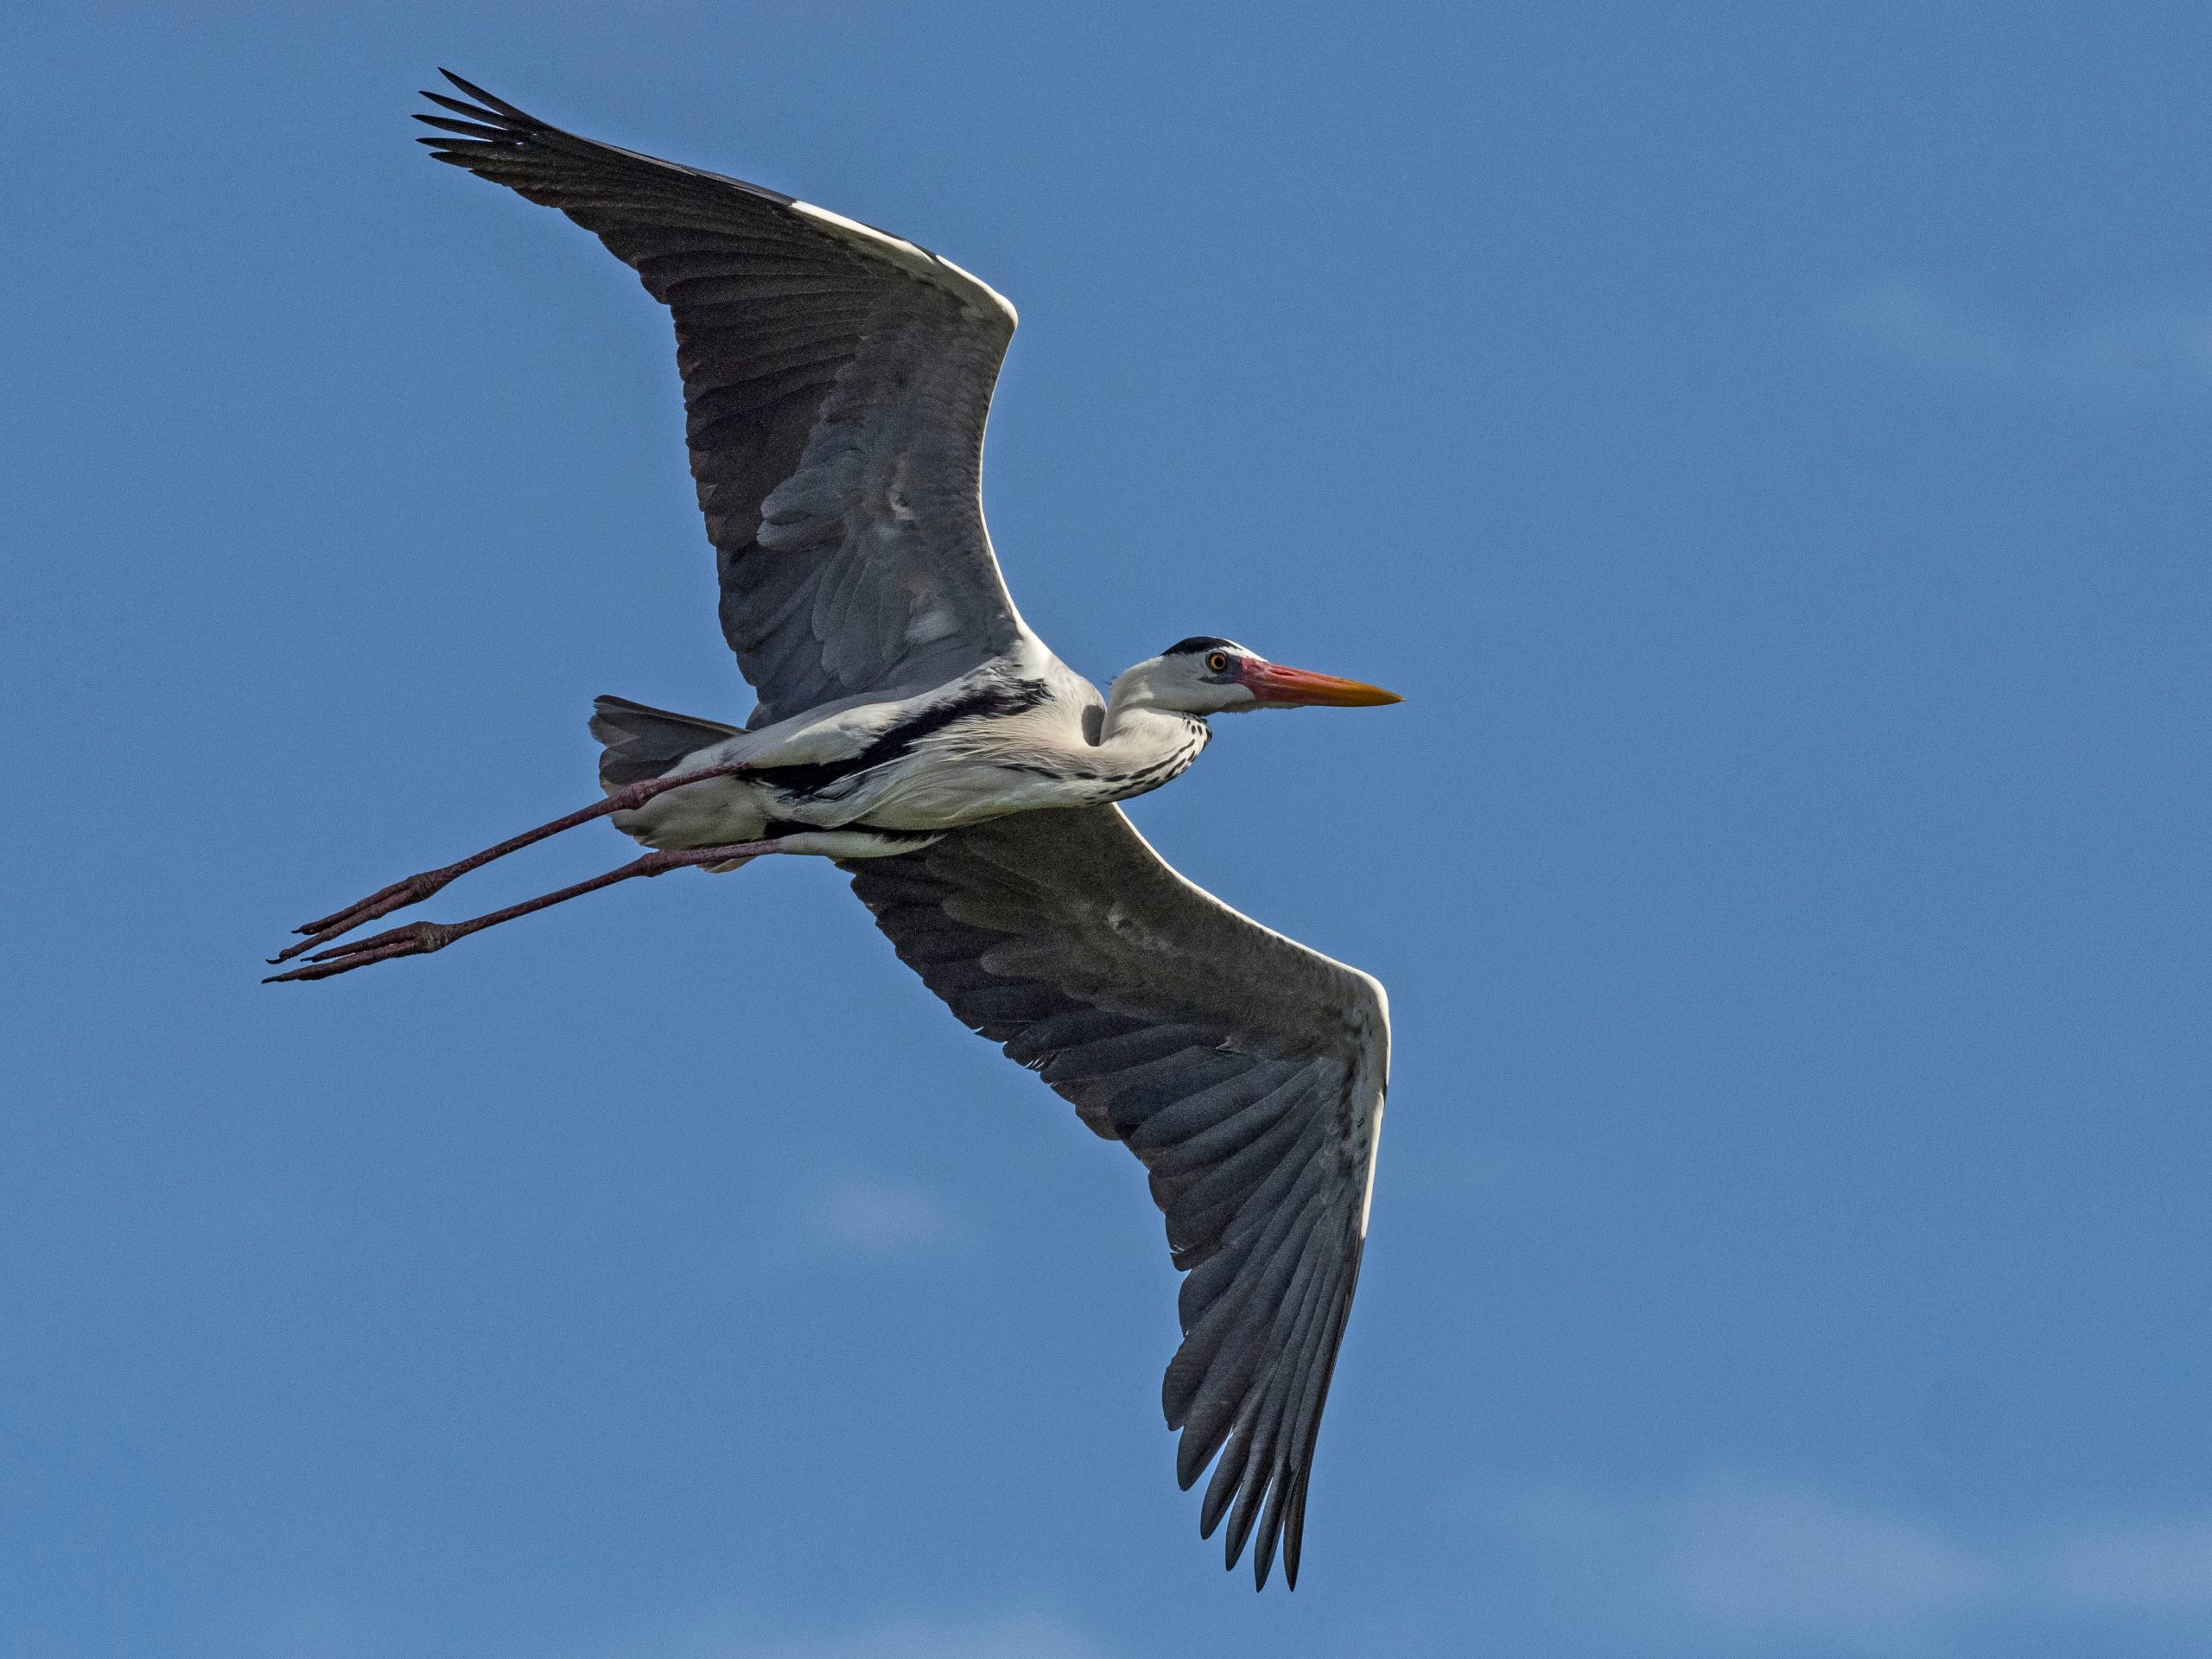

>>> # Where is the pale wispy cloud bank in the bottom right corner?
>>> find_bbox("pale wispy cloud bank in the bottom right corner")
[1509,1480,2212,1659]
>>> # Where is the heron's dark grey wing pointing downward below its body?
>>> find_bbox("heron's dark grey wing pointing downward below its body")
[845,807,1389,1584]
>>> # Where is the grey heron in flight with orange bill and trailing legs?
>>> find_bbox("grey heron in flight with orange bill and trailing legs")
[270,73,1398,1588]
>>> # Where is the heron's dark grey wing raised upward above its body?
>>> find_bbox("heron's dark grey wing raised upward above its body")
[416,75,1022,726]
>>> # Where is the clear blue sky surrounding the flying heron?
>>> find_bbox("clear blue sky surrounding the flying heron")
[0,0,2212,1659]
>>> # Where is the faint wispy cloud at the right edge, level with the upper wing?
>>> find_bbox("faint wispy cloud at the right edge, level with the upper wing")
[1832,279,2212,398]
